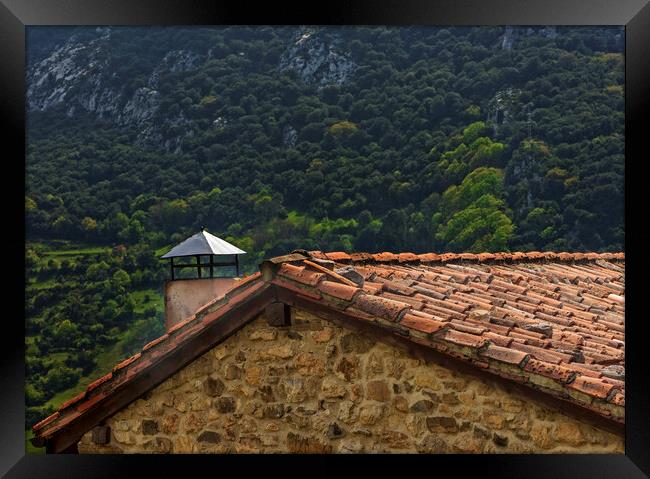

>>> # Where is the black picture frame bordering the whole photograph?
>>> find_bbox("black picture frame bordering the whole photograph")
[0,0,650,478]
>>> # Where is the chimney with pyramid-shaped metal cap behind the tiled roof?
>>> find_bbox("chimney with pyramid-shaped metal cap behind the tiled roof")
[161,228,246,331]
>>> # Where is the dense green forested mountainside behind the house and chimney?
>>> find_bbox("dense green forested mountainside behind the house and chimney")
[25,27,624,436]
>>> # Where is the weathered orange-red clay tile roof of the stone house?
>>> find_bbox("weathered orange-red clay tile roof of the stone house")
[33,250,625,450]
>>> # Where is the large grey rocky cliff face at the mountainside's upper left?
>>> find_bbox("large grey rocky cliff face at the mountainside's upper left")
[27,28,202,150]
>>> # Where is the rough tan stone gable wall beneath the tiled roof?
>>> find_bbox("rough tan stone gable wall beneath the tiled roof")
[79,311,624,453]
